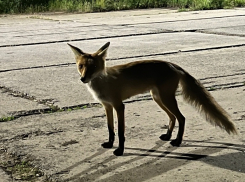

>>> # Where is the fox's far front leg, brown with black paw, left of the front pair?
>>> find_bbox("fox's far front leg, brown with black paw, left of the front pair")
[101,103,115,148]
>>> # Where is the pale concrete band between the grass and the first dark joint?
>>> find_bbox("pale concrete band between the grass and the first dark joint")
[0,10,245,46]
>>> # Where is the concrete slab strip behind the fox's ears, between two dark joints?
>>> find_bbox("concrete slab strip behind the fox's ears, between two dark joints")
[0,32,245,71]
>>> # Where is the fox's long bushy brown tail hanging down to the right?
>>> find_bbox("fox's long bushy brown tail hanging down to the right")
[177,67,237,134]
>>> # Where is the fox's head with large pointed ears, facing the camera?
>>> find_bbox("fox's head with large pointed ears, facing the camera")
[68,42,110,83]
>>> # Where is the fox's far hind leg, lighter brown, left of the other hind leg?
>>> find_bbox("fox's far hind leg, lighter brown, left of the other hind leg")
[151,89,176,141]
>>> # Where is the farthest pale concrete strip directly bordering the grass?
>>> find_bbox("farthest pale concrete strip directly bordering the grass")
[26,8,244,25]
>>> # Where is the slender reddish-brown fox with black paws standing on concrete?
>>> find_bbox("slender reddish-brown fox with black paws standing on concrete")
[68,42,237,156]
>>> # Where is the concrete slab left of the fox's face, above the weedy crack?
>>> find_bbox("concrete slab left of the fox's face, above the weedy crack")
[0,65,93,107]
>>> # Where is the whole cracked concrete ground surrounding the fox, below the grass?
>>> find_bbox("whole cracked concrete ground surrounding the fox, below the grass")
[0,8,245,182]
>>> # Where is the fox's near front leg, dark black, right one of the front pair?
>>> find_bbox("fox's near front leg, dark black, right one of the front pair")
[114,103,125,156]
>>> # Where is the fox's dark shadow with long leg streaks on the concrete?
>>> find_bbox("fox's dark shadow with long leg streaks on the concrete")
[59,140,245,181]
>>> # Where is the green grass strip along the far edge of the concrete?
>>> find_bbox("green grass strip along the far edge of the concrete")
[0,0,245,13]
